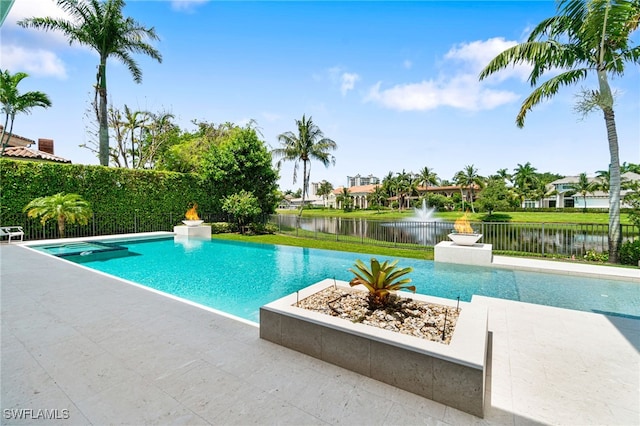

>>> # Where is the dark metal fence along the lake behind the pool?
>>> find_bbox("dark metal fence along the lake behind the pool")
[270,215,640,256]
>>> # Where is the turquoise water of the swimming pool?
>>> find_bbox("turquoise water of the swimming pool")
[58,238,640,322]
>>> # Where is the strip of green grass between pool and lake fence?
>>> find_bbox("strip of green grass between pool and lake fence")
[211,234,433,260]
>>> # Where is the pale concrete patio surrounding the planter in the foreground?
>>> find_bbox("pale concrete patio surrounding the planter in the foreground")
[0,245,640,425]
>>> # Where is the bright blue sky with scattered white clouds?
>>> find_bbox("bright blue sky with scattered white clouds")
[0,0,640,189]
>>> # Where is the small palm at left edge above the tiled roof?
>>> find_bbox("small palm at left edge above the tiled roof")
[0,70,51,155]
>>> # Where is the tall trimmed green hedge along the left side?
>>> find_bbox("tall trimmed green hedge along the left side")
[0,158,212,234]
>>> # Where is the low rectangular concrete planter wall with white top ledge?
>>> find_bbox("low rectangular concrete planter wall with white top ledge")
[260,279,488,417]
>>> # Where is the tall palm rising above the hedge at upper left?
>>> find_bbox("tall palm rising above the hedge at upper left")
[18,0,162,166]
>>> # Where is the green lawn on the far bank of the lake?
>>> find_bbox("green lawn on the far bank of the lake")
[278,209,631,224]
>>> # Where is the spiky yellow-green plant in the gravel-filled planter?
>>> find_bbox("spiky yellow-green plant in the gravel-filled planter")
[349,258,416,309]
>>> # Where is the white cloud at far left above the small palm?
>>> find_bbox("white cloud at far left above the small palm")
[0,44,67,80]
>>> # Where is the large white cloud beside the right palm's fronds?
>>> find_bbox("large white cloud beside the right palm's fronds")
[364,38,530,111]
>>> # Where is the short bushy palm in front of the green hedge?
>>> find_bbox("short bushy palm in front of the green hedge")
[24,192,93,238]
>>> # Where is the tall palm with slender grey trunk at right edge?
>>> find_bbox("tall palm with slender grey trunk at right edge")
[480,0,640,263]
